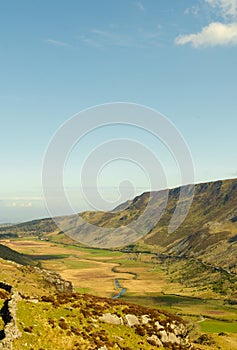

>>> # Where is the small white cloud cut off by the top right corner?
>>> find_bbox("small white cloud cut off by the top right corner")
[205,0,237,19]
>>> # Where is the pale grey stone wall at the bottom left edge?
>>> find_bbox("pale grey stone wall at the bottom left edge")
[0,282,21,350]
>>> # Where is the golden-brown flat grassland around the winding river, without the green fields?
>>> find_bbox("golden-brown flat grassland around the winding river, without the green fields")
[0,240,202,296]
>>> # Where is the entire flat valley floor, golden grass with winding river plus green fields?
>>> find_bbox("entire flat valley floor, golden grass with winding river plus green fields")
[0,238,237,348]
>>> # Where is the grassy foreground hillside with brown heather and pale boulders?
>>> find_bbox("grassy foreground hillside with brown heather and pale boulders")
[0,259,196,350]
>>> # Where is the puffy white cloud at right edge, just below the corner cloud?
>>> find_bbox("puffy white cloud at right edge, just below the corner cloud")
[175,22,237,47]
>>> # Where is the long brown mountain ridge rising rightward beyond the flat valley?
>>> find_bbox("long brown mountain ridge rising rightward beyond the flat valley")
[0,179,237,273]
